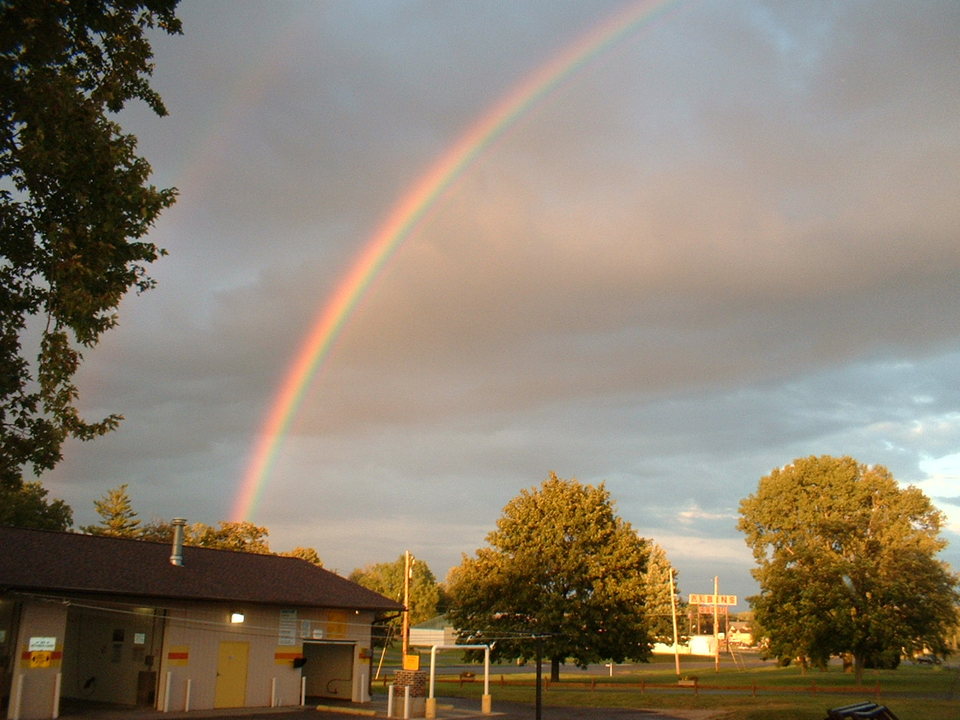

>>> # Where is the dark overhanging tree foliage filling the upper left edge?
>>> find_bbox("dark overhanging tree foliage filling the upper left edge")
[0,0,180,488]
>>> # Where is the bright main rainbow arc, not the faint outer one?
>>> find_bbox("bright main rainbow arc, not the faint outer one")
[230,0,680,522]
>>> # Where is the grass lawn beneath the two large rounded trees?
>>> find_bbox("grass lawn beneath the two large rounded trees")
[372,655,960,720]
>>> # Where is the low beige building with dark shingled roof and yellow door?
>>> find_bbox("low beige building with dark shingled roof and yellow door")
[0,527,401,720]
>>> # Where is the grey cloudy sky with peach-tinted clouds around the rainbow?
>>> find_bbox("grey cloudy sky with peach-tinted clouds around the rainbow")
[44,0,960,609]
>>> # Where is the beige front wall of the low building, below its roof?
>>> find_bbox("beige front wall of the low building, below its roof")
[7,601,374,720]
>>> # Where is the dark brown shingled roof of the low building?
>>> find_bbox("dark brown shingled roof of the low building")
[0,527,401,610]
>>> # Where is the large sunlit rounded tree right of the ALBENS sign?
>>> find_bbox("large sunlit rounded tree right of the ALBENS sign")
[739,456,958,682]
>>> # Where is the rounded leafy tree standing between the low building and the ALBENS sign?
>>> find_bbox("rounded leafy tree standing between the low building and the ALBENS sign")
[447,473,651,680]
